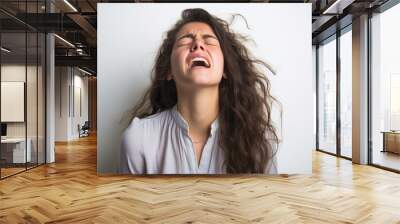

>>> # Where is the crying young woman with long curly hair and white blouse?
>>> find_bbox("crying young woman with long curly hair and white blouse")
[120,9,278,174]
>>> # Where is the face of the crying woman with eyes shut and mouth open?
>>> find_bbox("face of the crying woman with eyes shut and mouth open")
[167,22,224,87]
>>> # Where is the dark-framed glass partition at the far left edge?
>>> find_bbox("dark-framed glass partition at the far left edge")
[0,1,46,179]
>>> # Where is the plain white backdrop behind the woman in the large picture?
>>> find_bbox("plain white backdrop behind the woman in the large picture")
[97,3,315,174]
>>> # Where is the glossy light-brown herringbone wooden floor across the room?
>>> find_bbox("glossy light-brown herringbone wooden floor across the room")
[0,134,400,224]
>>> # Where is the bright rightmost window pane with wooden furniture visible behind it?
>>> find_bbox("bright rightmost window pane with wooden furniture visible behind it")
[370,4,400,171]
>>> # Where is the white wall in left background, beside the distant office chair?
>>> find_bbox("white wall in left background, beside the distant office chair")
[55,67,88,141]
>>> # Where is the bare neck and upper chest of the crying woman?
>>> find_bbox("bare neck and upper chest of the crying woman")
[177,87,219,141]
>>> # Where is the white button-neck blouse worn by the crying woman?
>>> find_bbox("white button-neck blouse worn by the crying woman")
[120,105,277,174]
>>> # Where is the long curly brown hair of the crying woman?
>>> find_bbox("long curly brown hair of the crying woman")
[132,8,278,174]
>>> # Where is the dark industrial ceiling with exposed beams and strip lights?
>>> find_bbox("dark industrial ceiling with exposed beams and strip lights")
[0,0,394,73]
